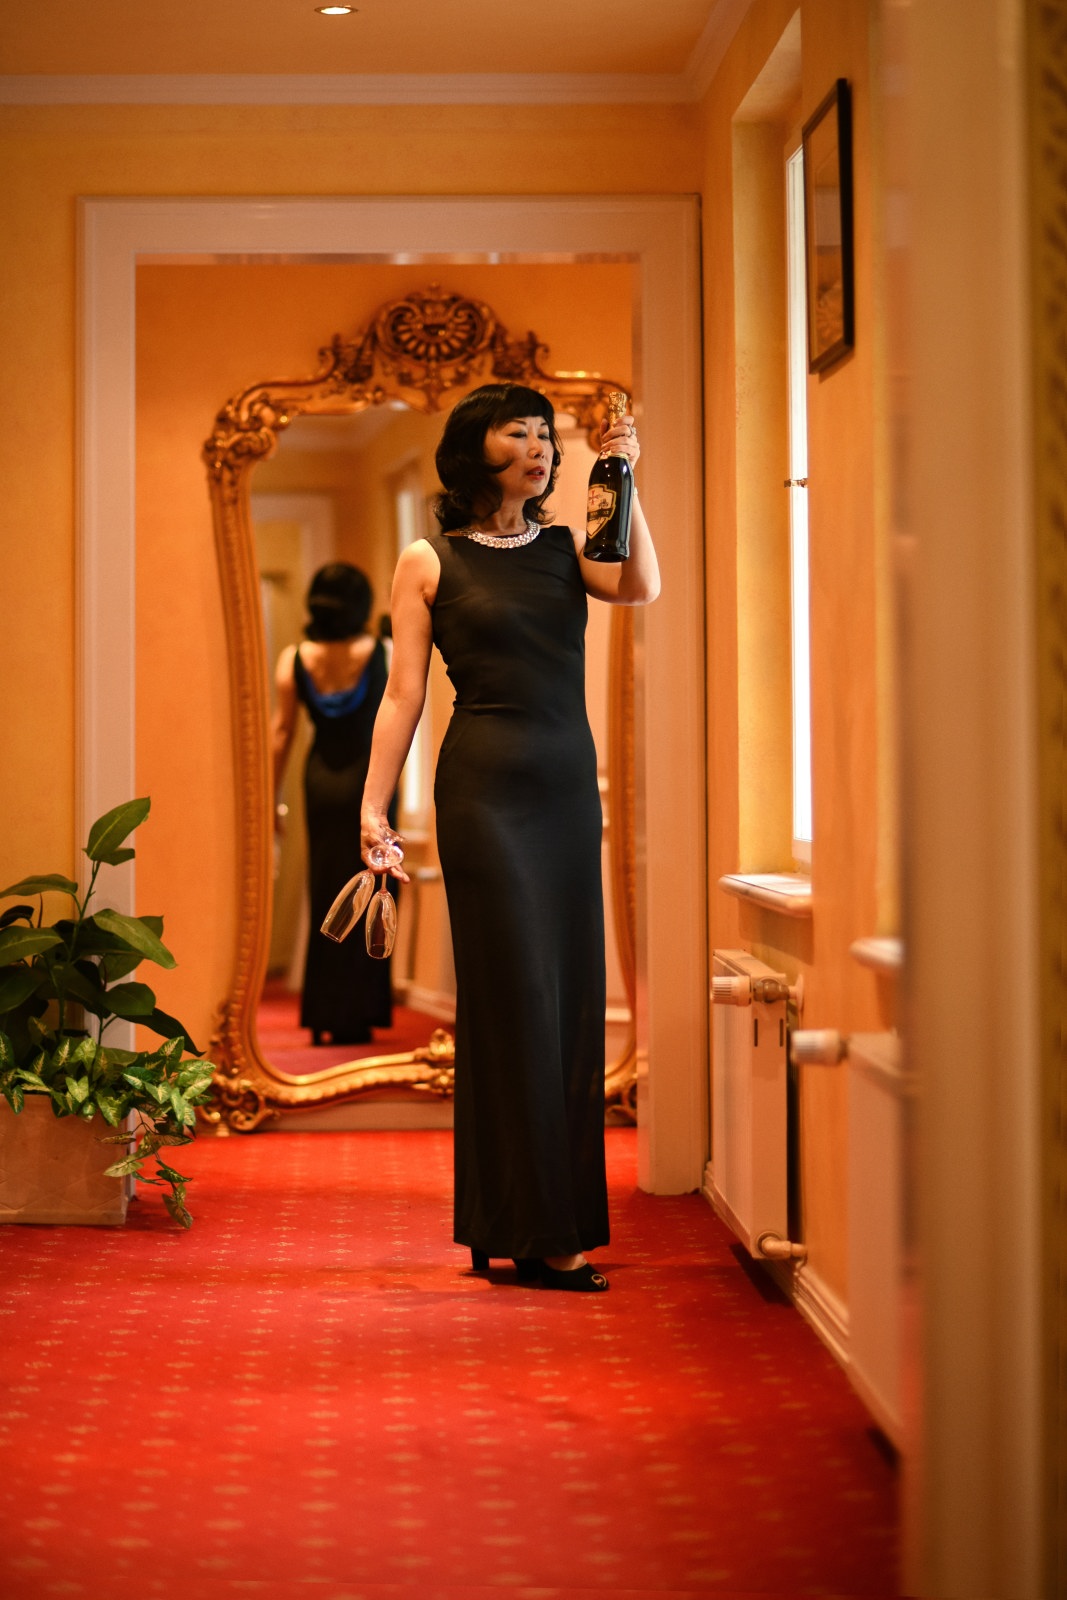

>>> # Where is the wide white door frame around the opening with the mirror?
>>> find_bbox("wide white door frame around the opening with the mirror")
[77,195,707,1194]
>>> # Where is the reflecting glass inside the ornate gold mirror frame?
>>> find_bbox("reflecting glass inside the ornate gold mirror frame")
[251,405,454,1074]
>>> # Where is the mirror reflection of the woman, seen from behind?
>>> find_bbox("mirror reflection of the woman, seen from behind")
[272,562,392,1045]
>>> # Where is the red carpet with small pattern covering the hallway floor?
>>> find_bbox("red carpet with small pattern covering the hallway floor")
[0,1128,897,1600]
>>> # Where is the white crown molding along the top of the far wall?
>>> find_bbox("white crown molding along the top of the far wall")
[0,72,694,106]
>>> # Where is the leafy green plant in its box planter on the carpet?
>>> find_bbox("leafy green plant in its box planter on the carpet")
[0,798,214,1227]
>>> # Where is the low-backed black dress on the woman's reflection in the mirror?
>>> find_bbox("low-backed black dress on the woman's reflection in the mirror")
[293,640,392,1045]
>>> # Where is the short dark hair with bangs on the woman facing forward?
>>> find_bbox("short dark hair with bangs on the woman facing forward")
[434,384,563,533]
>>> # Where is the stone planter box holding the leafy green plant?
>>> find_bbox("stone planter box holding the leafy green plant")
[0,1094,128,1227]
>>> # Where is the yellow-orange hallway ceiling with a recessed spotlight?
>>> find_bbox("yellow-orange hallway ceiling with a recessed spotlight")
[0,0,726,75]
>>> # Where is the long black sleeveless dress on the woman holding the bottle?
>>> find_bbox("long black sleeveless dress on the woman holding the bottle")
[430,528,608,1258]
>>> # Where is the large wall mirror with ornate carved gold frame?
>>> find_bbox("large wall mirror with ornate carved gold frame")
[203,283,635,1131]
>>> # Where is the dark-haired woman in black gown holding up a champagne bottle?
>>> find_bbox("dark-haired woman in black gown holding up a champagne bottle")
[363,384,659,1291]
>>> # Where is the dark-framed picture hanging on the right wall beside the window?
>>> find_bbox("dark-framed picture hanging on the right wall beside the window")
[803,78,854,373]
